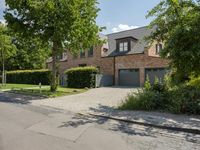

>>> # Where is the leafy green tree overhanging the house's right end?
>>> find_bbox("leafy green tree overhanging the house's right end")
[147,0,200,81]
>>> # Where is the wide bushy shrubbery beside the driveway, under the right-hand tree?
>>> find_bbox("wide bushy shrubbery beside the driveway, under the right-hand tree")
[119,79,200,114]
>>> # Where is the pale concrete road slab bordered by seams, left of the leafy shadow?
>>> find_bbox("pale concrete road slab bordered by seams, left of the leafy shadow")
[28,114,93,142]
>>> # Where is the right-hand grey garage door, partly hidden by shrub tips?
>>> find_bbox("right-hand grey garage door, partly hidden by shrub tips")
[145,68,168,84]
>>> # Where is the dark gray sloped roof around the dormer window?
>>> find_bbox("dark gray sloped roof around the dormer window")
[103,26,152,57]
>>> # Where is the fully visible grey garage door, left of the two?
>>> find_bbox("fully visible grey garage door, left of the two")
[119,69,140,87]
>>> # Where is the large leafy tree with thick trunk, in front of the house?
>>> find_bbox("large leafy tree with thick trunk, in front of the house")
[5,0,101,92]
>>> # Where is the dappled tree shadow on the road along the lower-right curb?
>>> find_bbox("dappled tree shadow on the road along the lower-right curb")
[58,105,200,143]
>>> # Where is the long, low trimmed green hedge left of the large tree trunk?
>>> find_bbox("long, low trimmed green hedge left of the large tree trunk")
[6,70,51,85]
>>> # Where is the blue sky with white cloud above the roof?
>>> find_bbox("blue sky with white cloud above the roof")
[0,0,160,33]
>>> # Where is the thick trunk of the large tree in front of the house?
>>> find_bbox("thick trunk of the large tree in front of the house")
[51,42,58,92]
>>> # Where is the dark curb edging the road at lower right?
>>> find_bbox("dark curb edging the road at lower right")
[79,113,200,135]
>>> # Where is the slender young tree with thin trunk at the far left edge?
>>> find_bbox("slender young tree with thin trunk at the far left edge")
[0,24,16,84]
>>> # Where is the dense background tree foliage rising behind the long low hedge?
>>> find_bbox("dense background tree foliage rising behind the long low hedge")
[5,34,50,70]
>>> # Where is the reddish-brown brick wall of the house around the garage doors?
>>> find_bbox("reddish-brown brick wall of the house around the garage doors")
[48,44,169,86]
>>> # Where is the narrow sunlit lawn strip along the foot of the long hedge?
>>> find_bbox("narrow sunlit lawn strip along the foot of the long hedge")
[0,84,39,91]
